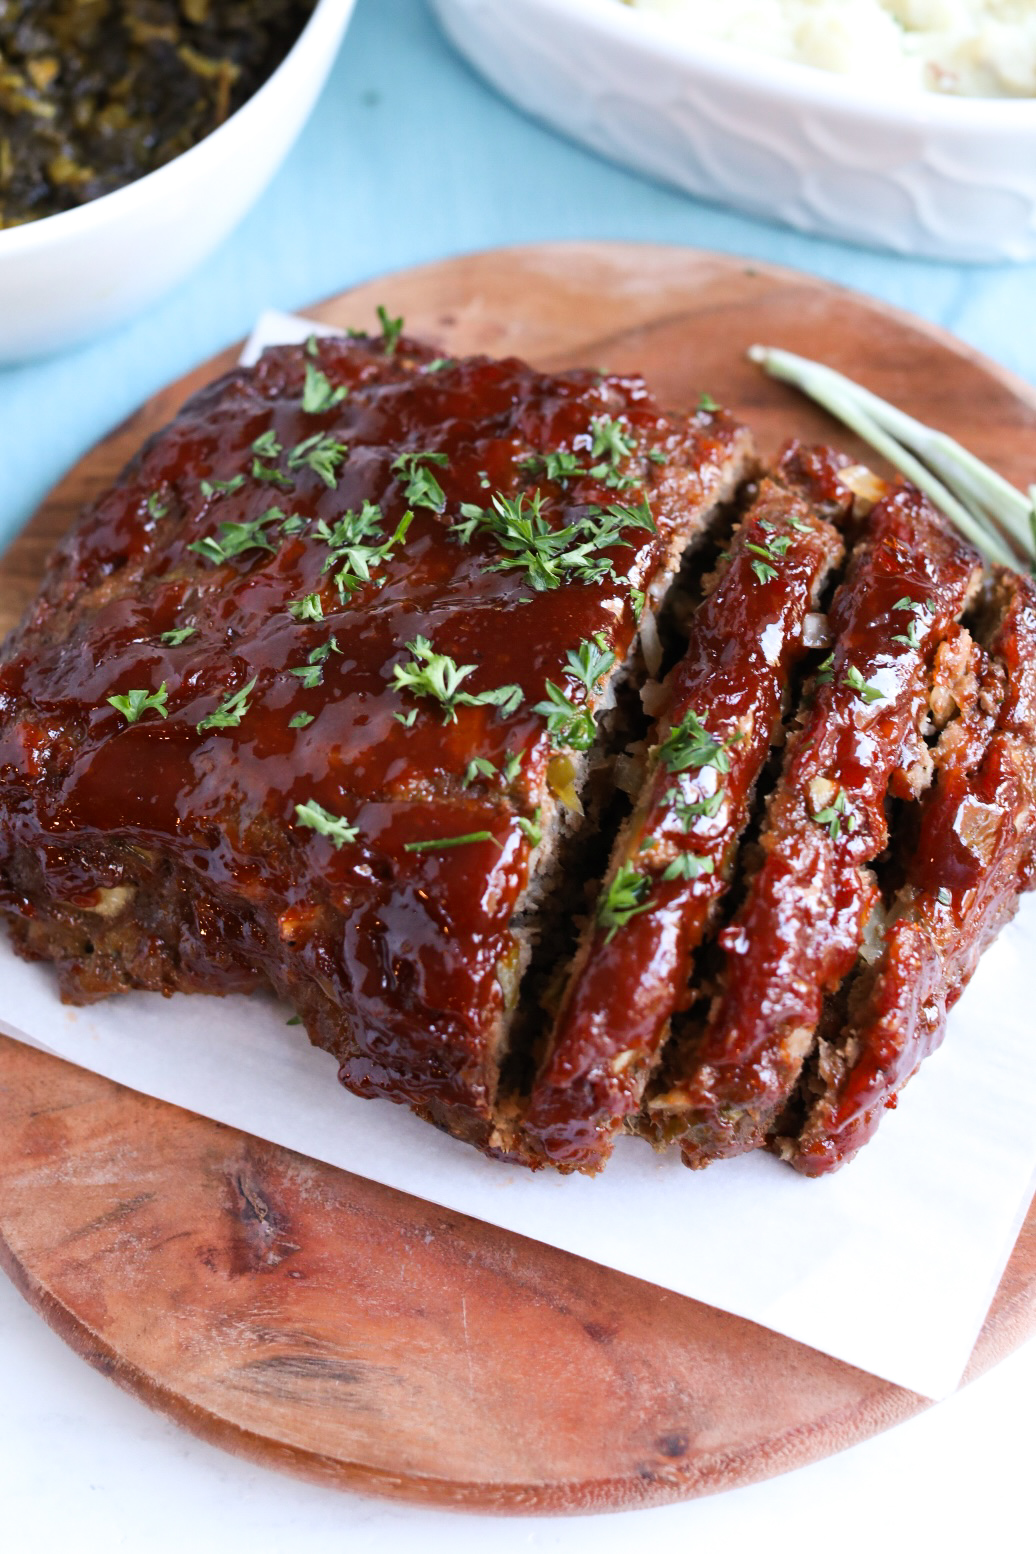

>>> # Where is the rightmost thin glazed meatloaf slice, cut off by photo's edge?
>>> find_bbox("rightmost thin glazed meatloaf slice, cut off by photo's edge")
[785,572,1036,1176]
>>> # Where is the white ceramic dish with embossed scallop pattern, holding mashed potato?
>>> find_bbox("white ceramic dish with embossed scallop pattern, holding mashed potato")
[432,0,1036,261]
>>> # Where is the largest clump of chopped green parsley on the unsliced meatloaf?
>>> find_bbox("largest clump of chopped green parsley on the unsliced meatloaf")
[450,491,655,592]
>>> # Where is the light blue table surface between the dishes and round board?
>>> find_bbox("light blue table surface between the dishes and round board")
[0,0,1036,556]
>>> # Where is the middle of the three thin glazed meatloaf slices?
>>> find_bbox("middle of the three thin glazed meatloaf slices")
[646,486,980,1167]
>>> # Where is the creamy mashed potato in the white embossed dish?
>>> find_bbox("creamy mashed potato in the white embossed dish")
[624,0,1036,96]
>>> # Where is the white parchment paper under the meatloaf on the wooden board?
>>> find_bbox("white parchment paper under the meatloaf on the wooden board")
[0,315,1036,1397]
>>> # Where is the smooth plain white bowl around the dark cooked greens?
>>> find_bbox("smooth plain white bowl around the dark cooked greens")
[0,0,356,364]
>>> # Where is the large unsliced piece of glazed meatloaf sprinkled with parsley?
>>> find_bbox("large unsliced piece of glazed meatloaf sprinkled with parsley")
[0,328,750,1145]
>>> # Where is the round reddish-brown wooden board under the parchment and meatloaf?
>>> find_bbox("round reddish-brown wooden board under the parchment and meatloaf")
[0,244,1036,1512]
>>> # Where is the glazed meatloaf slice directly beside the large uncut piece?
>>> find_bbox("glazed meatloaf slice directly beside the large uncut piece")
[522,450,848,1172]
